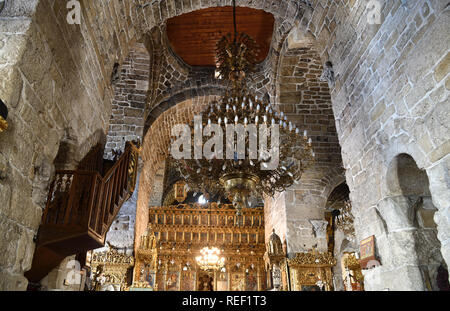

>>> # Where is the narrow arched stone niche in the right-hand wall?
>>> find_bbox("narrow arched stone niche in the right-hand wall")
[378,153,446,290]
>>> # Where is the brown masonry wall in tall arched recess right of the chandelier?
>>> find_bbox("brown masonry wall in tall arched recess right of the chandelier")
[266,36,344,255]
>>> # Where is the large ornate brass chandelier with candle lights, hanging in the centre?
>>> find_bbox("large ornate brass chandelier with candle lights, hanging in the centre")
[174,1,314,214]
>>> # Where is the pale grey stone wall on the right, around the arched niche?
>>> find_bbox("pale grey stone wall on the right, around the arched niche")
[298,1,450,290]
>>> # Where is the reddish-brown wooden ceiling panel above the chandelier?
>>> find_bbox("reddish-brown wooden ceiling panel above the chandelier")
[167,6,275,66]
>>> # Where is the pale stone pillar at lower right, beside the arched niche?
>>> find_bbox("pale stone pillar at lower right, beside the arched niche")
[357,196,426,291]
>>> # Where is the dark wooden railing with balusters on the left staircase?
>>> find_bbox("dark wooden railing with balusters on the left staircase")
[42,143,139,243]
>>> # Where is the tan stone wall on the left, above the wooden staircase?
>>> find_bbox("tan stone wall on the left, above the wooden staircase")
[0,1,118,290]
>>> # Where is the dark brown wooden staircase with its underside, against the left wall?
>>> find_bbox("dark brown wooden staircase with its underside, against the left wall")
[25,143,139,283]
